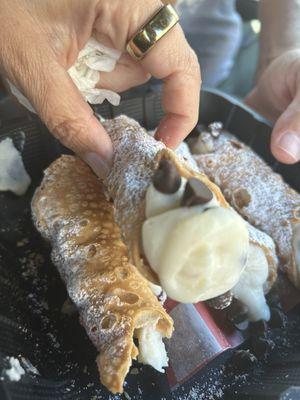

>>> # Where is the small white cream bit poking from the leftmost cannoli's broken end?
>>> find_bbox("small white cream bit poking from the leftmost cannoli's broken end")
[136,325,169,372]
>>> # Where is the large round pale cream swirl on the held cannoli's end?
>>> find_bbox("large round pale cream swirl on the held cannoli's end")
[142,206,249,303]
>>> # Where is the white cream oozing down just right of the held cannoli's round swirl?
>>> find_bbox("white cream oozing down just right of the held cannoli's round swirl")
[232,244,270,321]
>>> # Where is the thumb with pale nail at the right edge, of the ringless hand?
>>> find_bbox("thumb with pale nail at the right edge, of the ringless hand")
[271,95,300,164]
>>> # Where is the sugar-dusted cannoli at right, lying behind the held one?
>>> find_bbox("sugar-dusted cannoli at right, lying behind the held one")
[192,126,300,289]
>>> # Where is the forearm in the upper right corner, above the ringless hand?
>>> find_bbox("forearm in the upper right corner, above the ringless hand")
[258,0,300,75]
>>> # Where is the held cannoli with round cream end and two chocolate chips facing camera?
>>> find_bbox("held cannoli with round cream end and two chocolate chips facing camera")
[103,116,249,303]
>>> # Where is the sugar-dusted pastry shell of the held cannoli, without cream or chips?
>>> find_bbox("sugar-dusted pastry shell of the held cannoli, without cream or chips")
[103,115,227,283]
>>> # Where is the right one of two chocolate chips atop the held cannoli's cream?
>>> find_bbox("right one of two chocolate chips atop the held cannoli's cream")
[181,178,213,207]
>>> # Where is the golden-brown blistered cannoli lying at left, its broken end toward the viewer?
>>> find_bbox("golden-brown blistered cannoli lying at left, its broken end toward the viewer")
[32,156,173,393]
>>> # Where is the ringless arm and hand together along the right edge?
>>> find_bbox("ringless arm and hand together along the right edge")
[246,0,300,164]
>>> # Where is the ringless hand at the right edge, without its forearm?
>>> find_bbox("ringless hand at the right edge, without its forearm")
[245,50,300,164]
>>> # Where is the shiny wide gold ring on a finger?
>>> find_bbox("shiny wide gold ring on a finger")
[126,4,179,60]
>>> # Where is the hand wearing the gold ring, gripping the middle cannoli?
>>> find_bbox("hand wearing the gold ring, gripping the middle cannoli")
[0,0,200,176]
